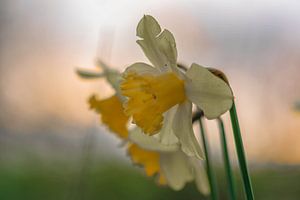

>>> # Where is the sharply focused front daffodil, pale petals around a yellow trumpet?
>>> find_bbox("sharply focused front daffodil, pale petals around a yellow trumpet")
[121,15,233,158]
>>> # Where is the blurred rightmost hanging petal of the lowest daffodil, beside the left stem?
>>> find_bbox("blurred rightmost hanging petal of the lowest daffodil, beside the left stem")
[190,158,210,195]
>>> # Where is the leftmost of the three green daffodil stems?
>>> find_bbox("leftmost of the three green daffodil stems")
[199,117,218,200]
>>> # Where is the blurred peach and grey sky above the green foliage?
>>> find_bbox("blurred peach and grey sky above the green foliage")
[0,0,300,164]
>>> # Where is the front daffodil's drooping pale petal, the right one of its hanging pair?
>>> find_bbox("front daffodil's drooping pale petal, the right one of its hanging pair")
[173,101,203,159]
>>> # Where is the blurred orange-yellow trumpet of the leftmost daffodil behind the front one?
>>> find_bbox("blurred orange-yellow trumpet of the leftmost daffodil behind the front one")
[89,95,128,139]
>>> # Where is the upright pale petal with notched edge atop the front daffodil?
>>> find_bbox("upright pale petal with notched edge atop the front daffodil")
[137,15,177,71]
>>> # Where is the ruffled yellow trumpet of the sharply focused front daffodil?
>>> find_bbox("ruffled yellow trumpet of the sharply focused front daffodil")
[121,72,186,135]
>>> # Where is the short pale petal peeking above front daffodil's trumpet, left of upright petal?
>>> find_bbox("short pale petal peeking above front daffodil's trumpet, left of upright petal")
[124,62,160,76]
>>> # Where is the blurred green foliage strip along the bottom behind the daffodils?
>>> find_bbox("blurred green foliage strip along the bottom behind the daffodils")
[0,161,300,200]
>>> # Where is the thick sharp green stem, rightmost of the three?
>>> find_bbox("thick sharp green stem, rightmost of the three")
[230,102,254,200]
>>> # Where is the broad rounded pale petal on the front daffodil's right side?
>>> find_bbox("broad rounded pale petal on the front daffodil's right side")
[185,64,233,119]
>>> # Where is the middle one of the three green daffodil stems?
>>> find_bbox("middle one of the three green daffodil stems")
[218,118,236,200]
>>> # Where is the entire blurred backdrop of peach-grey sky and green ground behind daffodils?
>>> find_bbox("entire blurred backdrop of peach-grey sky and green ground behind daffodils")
[0,0,300,199]
